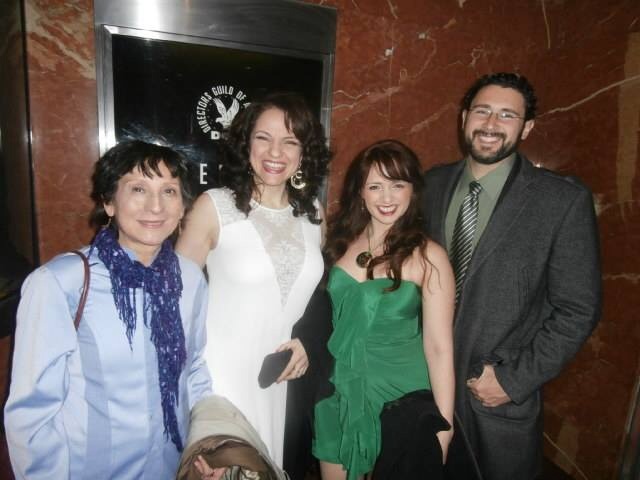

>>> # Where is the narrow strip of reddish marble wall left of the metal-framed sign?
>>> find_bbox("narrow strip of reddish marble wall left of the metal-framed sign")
[25,0,98,262]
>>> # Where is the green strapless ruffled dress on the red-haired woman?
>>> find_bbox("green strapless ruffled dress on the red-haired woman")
[313,267,431,480]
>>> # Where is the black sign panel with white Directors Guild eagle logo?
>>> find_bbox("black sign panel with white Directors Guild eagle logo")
[111,34,324,188]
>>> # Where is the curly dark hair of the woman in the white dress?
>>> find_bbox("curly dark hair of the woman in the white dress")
[220,92,331,224]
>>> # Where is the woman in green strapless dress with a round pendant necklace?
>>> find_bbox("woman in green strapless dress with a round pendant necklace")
[313,140,455,480]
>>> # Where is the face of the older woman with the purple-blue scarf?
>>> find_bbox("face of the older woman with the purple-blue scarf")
[104,162,184,265]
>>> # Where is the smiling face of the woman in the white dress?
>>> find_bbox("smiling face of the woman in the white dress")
[249,108,302,188]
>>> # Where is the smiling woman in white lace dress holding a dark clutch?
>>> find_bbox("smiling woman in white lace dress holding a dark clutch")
[176,93,330,465]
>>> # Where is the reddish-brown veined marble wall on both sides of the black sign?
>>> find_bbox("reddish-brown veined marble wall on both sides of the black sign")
[8,0,640,480]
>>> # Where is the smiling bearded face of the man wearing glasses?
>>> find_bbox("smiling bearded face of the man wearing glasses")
[462,85,534,165]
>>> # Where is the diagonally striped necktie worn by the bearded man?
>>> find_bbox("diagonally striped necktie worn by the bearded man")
[451,182,482,303]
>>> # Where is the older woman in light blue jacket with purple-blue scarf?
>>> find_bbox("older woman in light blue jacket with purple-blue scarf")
[5,141,211,480]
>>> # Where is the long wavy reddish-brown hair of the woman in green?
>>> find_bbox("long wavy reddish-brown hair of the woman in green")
[325,140,429,291]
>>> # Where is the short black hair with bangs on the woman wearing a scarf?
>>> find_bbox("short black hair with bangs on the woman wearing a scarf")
[89,140,196,230]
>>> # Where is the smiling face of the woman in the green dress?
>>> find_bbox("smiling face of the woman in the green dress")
[361,164,413,228]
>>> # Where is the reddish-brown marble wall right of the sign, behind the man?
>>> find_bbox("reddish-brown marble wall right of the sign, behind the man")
[318,0,640,480]
